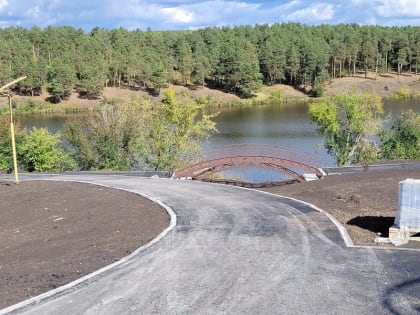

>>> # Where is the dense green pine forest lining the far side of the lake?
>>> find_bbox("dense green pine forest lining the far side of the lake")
[0,23,420,102]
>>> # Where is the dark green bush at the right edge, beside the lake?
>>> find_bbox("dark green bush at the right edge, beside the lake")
[379,110,420,159]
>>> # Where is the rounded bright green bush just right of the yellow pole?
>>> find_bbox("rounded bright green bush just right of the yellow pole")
[17,128,76,172]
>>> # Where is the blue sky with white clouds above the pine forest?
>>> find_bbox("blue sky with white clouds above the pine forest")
[0,0,420,31]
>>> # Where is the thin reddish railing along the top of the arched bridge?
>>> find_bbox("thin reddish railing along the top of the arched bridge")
[203,144,322,167]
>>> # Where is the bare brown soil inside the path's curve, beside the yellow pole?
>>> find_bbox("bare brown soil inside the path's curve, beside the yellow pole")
[0,181,169,309]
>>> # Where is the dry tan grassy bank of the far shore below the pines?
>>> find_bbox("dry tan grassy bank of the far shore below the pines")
[0,73,420,111]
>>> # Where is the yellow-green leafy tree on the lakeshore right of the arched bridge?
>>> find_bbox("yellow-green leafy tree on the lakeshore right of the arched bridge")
[309,91,383,165]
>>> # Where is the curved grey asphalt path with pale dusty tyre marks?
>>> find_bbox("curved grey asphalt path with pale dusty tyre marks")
[0,175,420,315]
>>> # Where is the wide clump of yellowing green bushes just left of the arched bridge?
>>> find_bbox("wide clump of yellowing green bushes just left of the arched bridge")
[65,90,215,171]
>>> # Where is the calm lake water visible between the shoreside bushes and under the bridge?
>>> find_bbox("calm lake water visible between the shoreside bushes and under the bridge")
[19,100,420,180]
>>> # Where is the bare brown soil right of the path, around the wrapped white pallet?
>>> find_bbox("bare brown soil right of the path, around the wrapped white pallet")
[263,169,420,249]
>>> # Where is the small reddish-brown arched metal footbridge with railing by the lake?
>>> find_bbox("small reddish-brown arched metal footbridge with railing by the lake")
[173,144,324,181]
